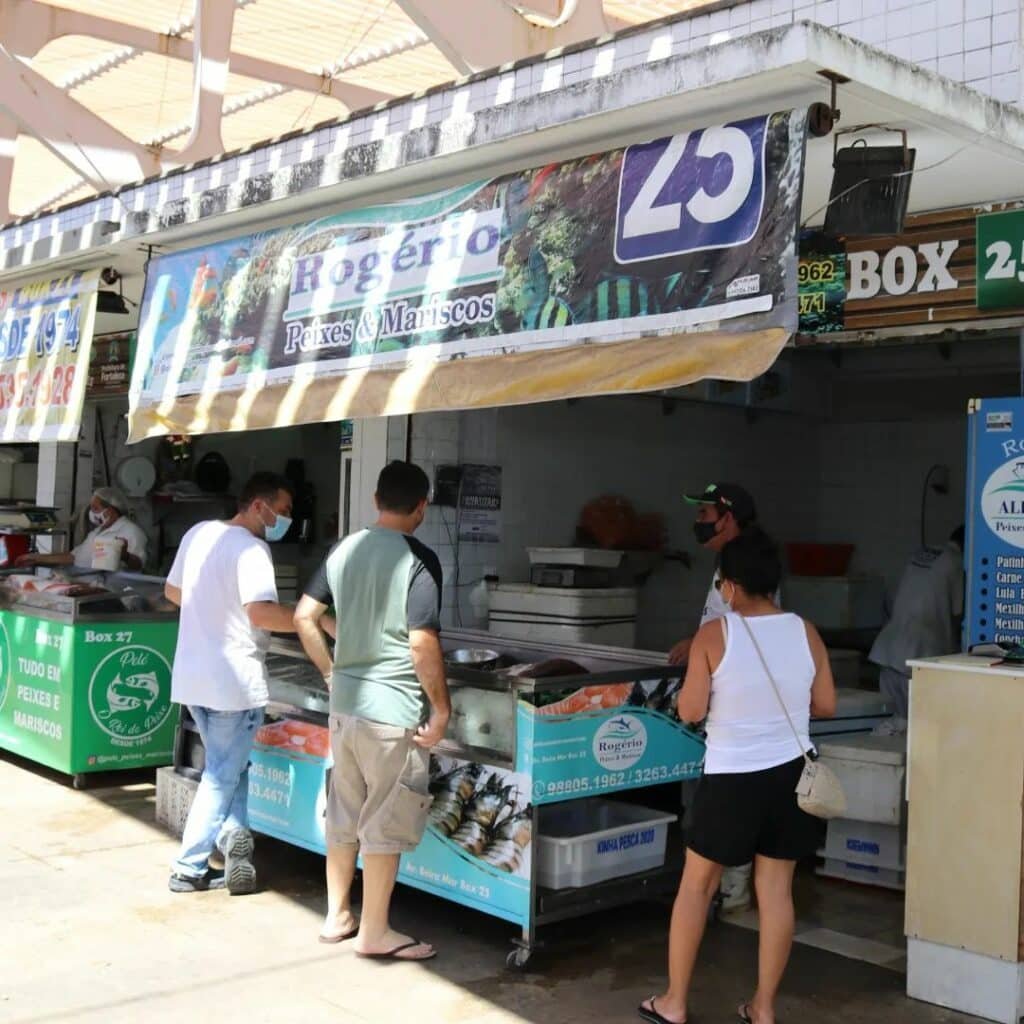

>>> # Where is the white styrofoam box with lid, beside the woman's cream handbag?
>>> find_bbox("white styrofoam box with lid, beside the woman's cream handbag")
[818,734,906,825]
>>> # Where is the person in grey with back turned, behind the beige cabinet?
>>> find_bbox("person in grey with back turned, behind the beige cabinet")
[868,526,964,733]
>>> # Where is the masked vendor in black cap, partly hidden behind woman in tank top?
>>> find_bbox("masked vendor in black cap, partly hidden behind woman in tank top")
[669,483,778,913]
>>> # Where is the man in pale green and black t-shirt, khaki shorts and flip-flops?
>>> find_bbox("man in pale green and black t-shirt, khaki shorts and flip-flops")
[295,462,452,961]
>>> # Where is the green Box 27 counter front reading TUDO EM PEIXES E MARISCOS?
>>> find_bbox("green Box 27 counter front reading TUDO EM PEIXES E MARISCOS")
[0,611,177,774]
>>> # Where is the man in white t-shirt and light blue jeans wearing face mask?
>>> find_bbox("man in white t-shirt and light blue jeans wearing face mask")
[165,473,295,895]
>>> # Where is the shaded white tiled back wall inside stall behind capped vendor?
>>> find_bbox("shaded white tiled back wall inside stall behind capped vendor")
[389,343,1017,649]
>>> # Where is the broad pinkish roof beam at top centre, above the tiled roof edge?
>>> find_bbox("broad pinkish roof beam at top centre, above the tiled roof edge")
[395,0,612,74]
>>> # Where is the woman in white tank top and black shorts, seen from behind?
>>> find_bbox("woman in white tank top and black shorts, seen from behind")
[639,528,836,1024]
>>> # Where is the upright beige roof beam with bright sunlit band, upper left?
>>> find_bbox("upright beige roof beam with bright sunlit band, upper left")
[176,0,237,164]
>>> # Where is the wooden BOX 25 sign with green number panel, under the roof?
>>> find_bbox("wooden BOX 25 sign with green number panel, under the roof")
[798,203,1024,335]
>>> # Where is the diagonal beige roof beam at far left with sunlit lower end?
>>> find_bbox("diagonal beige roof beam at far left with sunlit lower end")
[0,47,160,191]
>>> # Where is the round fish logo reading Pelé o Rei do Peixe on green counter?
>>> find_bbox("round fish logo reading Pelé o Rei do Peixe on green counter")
[89,644,172,745]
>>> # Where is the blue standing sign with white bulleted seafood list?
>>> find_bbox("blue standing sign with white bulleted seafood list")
[964,398,1024,647]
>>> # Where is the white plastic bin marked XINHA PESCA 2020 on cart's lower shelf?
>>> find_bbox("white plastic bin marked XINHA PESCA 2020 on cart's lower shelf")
[537,797,677,889]
